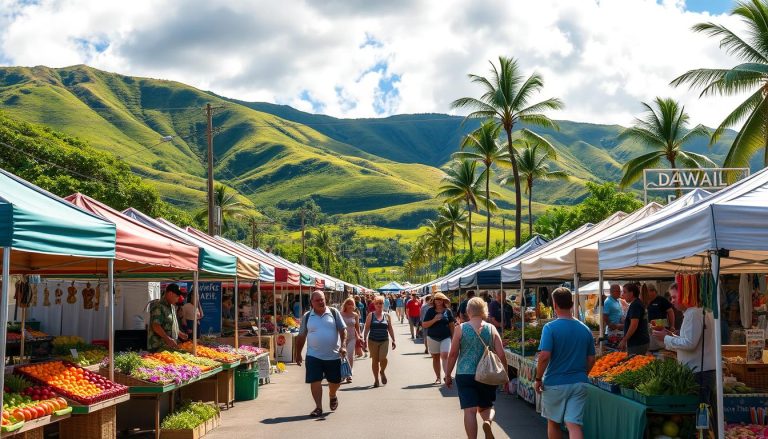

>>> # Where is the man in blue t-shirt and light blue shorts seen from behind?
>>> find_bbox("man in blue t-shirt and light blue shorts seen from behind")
[534,287,595,439]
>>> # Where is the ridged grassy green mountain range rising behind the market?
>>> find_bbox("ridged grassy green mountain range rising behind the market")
[0,65,752,229]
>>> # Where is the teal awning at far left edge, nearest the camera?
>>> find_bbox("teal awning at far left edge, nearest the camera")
[0,169,116,273]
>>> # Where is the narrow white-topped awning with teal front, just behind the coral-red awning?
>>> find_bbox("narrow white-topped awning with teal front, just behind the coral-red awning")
[123,207,237,277]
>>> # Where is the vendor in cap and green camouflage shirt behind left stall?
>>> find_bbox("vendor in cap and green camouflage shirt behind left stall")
[147,284,187,352]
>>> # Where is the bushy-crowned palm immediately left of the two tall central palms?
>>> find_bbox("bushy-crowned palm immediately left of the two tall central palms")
[438,160,483,254]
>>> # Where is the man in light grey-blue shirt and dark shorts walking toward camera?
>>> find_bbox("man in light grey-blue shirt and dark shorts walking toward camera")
[296,290,347,417]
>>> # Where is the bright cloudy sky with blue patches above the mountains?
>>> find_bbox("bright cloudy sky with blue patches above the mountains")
[0,0,752,126]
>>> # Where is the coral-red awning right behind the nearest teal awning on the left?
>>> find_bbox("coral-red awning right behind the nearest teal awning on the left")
[63,193,198,275]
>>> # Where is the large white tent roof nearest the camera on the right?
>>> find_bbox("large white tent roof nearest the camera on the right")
[600,169,768,275]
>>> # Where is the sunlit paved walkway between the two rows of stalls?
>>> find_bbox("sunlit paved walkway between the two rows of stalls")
[206,324,546,439]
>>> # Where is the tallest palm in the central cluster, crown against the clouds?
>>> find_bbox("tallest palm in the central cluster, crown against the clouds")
[451,56,564,246]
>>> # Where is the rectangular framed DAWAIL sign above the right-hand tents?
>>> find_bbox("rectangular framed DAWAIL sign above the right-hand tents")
[643,168,749,203]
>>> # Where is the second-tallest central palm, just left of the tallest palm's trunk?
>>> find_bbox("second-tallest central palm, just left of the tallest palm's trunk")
[453,120,509,259]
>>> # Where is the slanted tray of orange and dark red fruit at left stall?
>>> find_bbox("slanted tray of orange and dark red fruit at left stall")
[16,361,128,405]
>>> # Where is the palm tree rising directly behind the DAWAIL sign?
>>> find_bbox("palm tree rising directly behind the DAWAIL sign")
[619,97,715,196]
